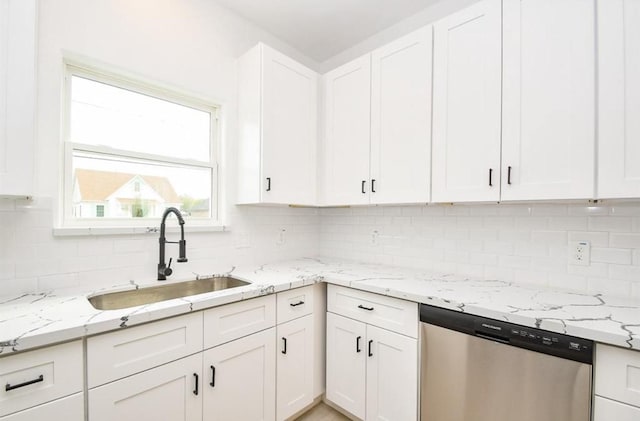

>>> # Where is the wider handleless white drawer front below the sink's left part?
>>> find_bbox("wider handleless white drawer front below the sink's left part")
[87,312,202,388]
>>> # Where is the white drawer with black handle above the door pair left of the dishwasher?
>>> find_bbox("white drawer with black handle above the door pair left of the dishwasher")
[327,285,418,338]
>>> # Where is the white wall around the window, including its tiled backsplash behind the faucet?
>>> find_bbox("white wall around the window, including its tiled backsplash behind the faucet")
[0,0,318,295]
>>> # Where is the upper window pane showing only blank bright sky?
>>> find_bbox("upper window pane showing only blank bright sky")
[70,75,211,162]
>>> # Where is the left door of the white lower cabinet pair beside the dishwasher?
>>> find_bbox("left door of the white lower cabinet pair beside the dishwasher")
[327,313,367,419]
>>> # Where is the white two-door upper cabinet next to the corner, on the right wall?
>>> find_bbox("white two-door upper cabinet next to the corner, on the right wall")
[321,26,432,205]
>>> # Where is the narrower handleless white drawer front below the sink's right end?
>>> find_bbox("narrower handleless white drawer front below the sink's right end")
[204,295,276,348]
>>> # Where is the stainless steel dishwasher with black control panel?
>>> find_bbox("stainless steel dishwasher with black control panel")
[420,304,593,421]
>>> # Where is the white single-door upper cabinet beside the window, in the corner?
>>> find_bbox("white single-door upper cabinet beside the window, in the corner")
[238,44,318,205]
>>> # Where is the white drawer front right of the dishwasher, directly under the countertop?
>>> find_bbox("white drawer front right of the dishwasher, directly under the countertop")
[595,344,640,407]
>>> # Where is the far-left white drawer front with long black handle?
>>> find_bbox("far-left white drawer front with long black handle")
[0,341,84,416]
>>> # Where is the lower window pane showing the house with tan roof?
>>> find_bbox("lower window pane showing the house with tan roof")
[72,151,212,218]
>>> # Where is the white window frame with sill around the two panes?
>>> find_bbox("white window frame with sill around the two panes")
[54,59,225,236]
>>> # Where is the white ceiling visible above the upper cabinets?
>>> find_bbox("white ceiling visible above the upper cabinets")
[212,0,439,63]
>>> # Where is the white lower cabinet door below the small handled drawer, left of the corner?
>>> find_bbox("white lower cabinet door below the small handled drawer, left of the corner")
[276,315,314,420]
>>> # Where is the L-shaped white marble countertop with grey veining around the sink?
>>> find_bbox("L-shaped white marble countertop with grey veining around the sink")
[0,258,640,355]
